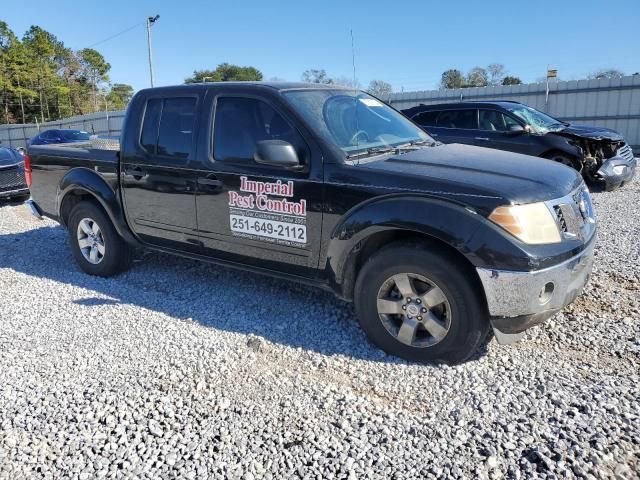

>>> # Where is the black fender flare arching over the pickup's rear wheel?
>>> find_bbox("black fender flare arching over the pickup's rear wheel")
[56,167,139,245]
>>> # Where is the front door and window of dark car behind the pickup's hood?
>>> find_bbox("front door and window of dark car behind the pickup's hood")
[475,108,532,155]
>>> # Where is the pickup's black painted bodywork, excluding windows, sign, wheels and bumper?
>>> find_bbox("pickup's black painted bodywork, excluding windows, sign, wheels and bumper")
[29,83,584,300]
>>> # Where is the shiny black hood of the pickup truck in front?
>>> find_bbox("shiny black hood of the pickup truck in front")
[361,144,582,204]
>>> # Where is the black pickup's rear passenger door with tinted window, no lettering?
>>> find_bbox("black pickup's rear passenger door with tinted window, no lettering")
[121,95,200,252]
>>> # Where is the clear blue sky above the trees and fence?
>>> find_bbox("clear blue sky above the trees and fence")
[0,0,640,91]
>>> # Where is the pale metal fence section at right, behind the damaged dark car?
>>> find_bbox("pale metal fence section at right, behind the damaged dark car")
[389,75,640,151]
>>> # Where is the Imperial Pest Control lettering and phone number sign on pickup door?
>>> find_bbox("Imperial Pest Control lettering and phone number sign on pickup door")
[229,177,307,247]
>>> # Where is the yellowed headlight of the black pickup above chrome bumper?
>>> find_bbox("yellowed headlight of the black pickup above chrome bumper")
[489,202,562,245]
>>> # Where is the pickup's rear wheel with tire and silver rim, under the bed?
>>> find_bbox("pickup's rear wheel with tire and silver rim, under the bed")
[68,201,132,277]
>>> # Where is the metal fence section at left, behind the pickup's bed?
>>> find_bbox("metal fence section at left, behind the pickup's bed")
[0,110,125,147]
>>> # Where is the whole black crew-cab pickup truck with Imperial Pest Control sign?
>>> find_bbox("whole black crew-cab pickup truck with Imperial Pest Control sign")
[25,82,596,363]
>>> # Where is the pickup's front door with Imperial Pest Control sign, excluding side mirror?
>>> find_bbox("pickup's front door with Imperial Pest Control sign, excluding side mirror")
[197,92,322,276]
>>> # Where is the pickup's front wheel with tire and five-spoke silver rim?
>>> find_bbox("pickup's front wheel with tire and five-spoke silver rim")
[354,243,490,364]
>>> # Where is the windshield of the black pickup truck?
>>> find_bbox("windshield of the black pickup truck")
[284,89,435,158]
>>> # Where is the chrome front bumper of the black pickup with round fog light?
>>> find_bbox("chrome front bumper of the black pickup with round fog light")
[477,235,596,334]
